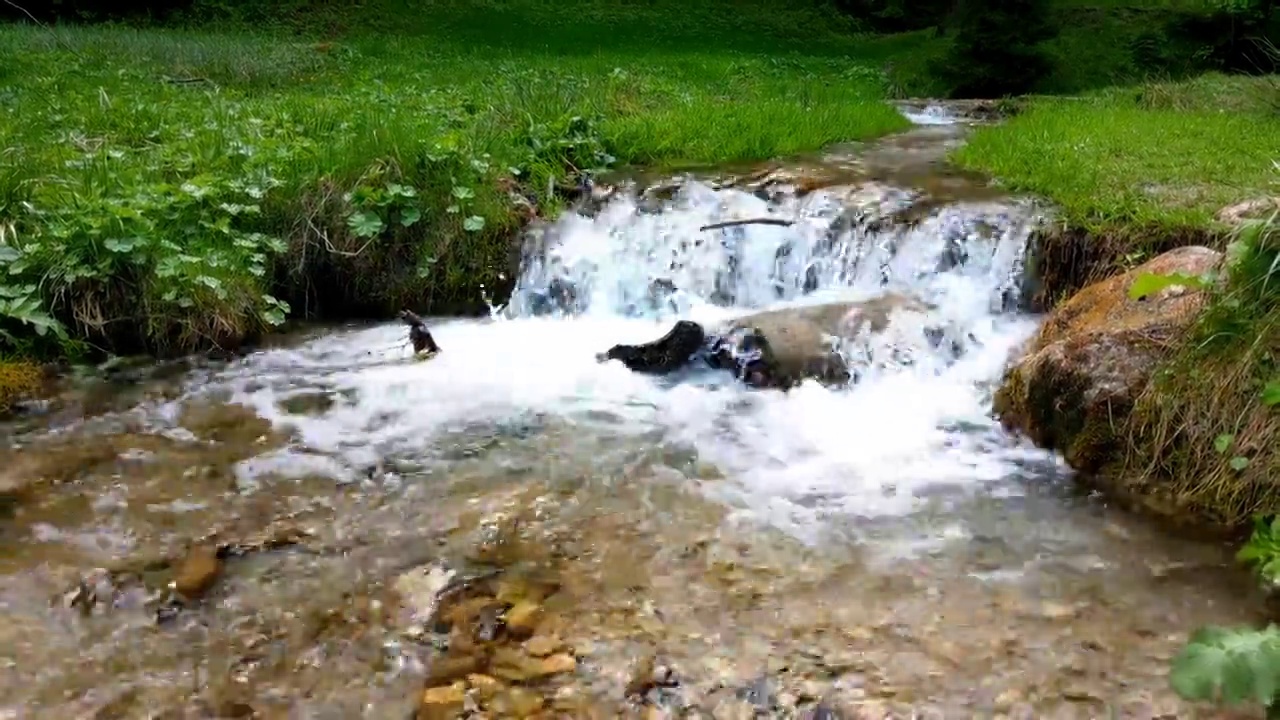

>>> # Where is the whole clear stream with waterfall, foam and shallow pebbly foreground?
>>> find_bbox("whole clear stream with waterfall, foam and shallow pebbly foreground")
[0,109,1257,720]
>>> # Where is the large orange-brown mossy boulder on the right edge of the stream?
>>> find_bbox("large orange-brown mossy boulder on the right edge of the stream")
[995,246,1222,475]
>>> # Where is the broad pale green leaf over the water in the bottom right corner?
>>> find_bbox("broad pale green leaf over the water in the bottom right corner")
[1169,625,1280,717]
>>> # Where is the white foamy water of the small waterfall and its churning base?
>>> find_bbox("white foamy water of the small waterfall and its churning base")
[199,163,1052,525]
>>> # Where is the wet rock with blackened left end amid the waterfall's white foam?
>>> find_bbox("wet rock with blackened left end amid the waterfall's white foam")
[598,293,929,389]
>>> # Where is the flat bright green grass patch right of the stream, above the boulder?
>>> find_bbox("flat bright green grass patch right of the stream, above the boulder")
[954,74,1280,234]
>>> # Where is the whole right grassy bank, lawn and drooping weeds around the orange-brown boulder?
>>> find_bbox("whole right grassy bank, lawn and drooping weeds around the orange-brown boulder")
[955,76,1280,524]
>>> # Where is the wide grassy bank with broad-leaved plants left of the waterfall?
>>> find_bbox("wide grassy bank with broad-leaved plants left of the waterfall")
[0,9,921,352]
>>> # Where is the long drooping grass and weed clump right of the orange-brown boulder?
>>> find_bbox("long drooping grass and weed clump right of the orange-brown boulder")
[1125,213,1280,525]
